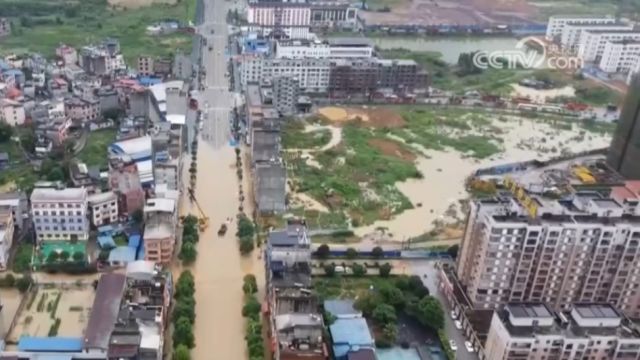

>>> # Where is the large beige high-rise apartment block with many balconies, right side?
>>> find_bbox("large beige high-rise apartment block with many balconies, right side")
[457,193,640,318]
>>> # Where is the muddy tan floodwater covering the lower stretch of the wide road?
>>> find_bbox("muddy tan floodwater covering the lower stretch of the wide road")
[184,140,264,360]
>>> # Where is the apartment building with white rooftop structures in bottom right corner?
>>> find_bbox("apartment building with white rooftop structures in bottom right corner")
[480,303,640,360]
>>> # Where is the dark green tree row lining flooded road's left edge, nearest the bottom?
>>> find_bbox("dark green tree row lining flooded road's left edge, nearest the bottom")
[172,270,196,352]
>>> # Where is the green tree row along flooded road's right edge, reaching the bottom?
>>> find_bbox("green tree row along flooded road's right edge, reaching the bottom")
[242,274,264,360]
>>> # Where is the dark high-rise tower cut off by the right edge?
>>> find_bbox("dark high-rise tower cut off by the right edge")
[607,76,640,180]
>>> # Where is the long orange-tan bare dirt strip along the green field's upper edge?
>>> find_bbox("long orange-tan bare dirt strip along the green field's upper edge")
[318,106,405,128]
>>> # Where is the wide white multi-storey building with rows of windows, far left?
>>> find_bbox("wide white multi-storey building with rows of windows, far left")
[31,188,89,241]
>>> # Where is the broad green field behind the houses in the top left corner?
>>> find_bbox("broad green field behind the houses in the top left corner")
[0,0,196,65]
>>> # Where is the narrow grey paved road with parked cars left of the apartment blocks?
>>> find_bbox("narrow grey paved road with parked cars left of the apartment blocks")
[409,261,478,360]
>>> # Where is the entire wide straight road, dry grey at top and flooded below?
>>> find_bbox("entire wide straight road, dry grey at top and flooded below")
[183,0,265,360]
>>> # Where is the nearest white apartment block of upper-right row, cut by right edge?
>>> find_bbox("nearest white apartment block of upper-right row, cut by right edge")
[598,39,640,73]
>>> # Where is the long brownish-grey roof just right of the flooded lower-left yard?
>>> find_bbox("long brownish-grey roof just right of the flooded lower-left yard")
[84,274,126,350]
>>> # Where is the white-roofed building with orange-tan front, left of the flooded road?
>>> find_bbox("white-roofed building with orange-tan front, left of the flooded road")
[144,198,178,264]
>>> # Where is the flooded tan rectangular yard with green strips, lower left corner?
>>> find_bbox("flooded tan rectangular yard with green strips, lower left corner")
[8,286,95,342]
